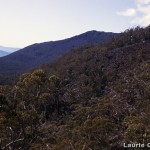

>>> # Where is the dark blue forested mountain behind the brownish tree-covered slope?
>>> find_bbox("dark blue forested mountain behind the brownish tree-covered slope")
[0,31,116,79]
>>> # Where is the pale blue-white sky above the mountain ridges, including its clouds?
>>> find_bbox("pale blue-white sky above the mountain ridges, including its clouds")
[0,0,150,48]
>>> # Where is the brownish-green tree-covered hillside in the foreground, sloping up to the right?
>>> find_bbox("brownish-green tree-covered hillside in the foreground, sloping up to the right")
[0,26,150,150]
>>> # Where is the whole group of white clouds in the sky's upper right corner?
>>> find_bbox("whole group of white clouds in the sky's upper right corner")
[117,0,150,26]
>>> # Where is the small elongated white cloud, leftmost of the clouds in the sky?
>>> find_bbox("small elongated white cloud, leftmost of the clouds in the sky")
[117,8,136,17]
